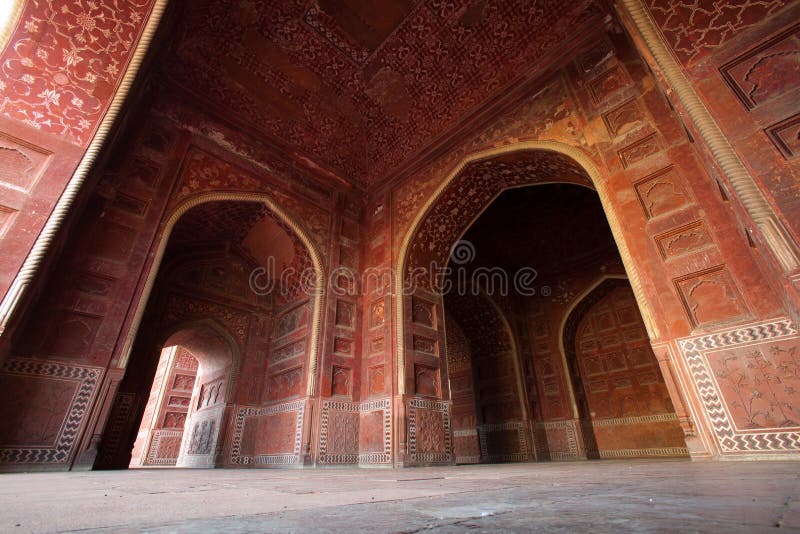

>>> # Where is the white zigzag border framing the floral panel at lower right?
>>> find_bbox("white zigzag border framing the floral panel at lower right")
[678,318,800,454]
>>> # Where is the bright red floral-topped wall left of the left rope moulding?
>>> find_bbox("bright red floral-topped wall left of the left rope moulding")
[0,0,161,306]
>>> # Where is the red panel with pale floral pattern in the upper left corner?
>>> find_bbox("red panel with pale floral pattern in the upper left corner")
[0,0,155,144]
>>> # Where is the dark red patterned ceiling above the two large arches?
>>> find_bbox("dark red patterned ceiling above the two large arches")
[161,0,598,185]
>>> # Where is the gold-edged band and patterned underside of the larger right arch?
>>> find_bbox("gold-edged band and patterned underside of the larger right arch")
[394,142,685,464]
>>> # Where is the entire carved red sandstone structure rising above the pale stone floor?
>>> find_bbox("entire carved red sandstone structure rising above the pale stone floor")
[0,0,800,478]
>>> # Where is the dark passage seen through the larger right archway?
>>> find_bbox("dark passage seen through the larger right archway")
[444,184,687,463]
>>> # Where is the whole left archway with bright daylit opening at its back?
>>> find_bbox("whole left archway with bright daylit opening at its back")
[96,197,323,468]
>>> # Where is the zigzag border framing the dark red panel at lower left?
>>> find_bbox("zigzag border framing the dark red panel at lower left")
[0,358,104,464]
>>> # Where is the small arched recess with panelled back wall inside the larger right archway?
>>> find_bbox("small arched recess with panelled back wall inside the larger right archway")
[561,278,688,458]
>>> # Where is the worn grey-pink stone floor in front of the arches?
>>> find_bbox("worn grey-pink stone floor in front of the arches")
[0,461,800,533]
